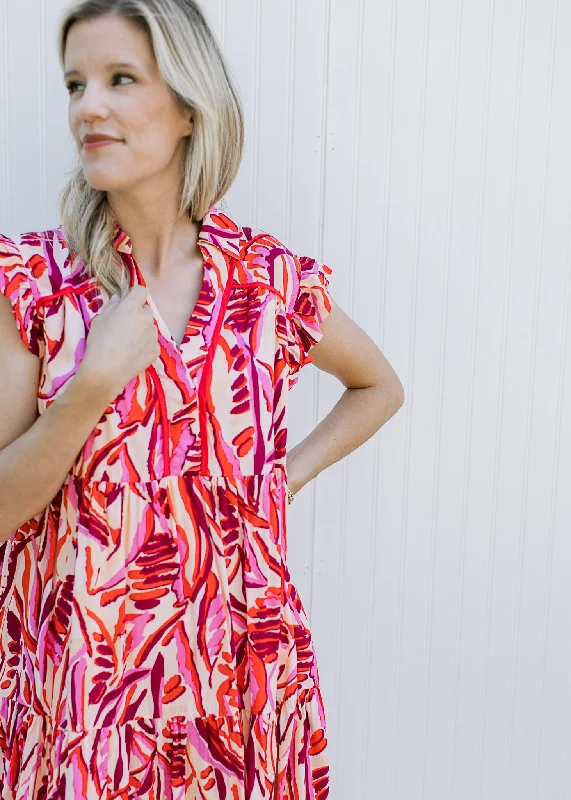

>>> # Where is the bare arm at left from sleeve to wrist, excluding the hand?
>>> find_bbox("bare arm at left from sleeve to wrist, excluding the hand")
[0,296,112,542]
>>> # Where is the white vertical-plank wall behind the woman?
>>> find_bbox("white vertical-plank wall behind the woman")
[0,0,571,800]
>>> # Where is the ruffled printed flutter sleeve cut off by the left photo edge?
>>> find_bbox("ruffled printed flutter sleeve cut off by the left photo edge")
[0,233,42,356]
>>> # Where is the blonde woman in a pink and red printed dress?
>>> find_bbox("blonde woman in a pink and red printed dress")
[0,0,403,800]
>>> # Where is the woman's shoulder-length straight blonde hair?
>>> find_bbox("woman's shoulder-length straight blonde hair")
[58,0,244,296]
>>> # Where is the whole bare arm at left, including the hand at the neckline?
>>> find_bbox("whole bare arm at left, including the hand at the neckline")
[0,285,160,542]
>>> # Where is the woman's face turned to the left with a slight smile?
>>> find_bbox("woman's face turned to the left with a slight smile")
[64,14,192,191]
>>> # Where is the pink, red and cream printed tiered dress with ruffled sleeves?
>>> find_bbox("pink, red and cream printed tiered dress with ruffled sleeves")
[0,206,331,800]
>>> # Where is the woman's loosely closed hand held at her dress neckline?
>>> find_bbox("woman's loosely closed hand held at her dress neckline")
[78,285,160,399]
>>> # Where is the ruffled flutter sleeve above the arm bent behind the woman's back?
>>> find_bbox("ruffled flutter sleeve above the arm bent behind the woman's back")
[286,256,333,387]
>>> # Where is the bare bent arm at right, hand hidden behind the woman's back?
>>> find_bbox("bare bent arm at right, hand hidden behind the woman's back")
[287,297,404,494]
